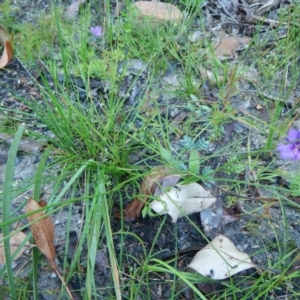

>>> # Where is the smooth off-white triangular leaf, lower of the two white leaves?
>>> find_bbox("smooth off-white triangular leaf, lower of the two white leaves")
[188,234,257,279]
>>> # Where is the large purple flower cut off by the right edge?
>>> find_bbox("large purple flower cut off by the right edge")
[277,129,300,160]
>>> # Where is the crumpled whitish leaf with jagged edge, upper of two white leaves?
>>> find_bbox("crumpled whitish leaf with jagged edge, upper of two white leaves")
[150,183,216,223]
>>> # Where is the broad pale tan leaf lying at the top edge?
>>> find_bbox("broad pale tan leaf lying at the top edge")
[134,1,183,21]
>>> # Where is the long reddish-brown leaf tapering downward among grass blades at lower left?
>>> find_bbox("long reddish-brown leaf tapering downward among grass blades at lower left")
[26,198,56,270]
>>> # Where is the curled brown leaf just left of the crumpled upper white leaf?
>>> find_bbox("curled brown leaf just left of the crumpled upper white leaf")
[124,167,178,222]
